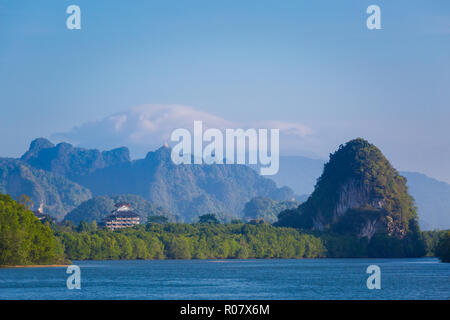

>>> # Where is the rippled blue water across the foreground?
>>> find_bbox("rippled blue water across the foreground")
[0,258,450,299]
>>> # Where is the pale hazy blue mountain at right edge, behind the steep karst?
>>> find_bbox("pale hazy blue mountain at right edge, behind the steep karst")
[401,172,450,230]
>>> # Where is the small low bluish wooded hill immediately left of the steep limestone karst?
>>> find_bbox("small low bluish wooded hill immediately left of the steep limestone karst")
[243,197,300,223]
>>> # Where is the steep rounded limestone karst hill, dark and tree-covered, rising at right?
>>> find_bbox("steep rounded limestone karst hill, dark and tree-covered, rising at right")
[278,138,417,239]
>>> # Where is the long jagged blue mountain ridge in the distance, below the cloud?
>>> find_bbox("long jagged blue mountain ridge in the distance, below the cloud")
[10,138,294,221]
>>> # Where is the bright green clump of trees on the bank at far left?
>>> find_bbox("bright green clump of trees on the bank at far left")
[0,194,64,265]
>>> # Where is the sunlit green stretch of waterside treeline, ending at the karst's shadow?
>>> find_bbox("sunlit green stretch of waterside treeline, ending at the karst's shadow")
[56,223,326,260]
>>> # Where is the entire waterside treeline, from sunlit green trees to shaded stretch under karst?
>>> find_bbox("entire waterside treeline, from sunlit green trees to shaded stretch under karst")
[56,220,445,260]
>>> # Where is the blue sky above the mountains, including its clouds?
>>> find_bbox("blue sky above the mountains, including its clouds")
[0,0,450,182]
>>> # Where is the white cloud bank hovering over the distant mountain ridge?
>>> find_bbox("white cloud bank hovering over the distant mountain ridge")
[51,105,312,158]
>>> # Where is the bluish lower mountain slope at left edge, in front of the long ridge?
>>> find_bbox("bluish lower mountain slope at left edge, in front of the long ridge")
[0,158,92,219]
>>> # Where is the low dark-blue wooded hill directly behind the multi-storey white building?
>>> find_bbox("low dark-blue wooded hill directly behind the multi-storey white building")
[64,194,178,224]
